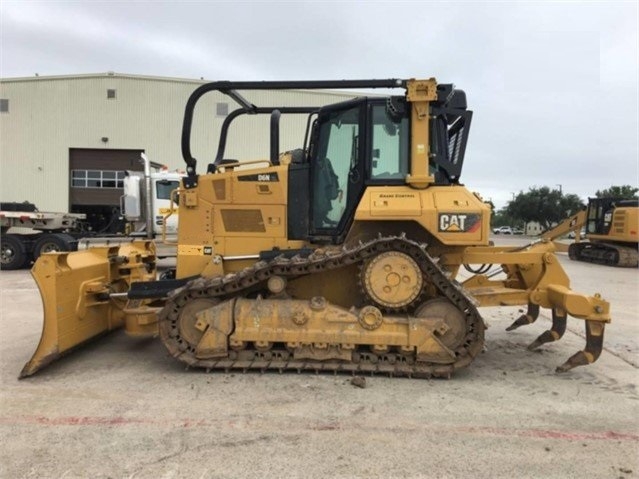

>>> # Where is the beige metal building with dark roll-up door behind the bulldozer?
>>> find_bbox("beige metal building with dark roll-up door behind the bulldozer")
[0,72,352,231]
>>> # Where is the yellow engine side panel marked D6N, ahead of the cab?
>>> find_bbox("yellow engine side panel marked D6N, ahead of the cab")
[177,165,305,278]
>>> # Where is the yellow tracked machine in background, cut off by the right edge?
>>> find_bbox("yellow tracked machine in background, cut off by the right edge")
[540,198,639,268]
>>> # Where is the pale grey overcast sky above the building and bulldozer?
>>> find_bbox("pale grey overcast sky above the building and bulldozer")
[0,0,639,207]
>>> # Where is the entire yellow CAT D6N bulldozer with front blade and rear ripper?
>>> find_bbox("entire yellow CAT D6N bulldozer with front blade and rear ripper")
[20,78,610,378]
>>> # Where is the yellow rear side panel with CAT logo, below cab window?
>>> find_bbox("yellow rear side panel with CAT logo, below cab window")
[355,186,490,246]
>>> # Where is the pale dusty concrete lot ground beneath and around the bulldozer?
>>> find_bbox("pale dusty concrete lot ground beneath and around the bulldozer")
[0,238,639,479]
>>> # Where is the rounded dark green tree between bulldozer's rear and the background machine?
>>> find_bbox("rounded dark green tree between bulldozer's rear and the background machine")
[506,186,585,229]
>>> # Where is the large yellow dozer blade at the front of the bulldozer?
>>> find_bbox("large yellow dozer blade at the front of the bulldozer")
[19,242,155,378]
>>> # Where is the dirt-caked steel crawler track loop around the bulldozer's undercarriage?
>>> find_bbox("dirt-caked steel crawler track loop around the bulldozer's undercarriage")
[159,236,485,378]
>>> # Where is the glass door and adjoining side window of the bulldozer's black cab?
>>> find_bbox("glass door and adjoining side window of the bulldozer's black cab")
[309,98,410,240]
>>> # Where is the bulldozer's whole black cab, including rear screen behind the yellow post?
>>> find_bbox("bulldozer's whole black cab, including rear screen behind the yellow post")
[304,85,472,243]
